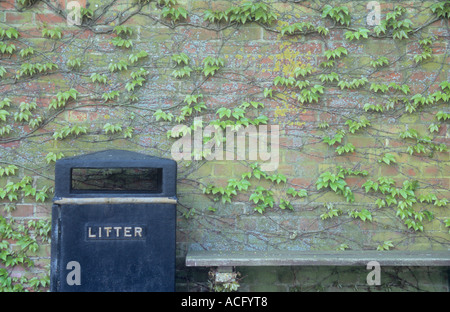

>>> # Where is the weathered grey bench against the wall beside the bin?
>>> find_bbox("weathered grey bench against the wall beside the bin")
[186,250,450,282]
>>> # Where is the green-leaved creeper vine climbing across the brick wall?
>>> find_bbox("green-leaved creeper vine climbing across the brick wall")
[0,0,450,291]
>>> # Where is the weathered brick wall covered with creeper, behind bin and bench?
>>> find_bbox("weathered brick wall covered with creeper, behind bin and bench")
[0,0,450,291]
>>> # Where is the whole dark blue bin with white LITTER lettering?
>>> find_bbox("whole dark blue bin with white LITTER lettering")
[50,150,177,292]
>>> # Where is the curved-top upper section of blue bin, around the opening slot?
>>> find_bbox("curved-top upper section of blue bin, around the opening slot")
[55,150,177,199]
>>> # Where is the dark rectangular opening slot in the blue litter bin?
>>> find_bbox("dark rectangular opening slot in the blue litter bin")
[71,168,162,193]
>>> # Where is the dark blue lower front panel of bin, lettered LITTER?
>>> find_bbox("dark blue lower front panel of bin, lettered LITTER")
[52,204,176,291]
